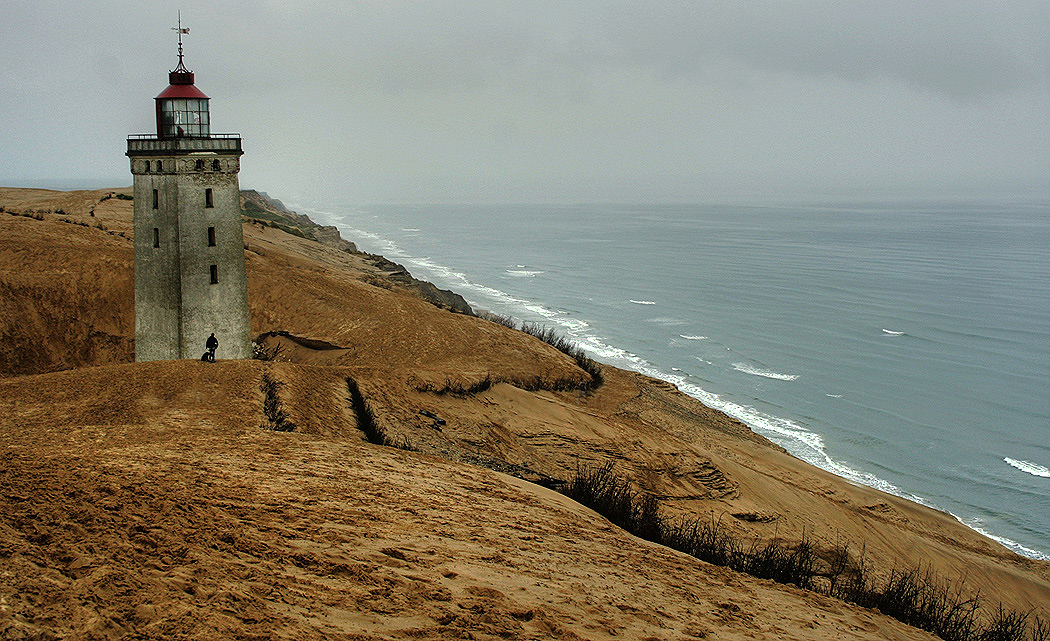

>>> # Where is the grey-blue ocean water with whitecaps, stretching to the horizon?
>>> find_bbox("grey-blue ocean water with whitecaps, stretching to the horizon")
[296,201,1050,559]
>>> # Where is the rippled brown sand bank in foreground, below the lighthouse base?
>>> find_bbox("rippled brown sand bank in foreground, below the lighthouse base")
[0,361,928,639]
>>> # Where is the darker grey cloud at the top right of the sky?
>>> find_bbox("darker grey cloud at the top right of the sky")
[607,1,1050,99]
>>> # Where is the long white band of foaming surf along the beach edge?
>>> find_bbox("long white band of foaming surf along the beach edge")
[295,198,1050,561]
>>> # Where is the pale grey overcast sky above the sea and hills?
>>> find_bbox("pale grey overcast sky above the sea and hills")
[0,0,1050,204]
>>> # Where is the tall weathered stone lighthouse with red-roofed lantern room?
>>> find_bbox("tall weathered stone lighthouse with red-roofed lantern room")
[127,20,252,361]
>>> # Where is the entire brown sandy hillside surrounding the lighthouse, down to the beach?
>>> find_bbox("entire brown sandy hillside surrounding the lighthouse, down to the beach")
[0,189,1050,639]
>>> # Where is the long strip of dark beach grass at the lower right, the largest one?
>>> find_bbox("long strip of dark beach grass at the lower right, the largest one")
[561,463,1050,641]
